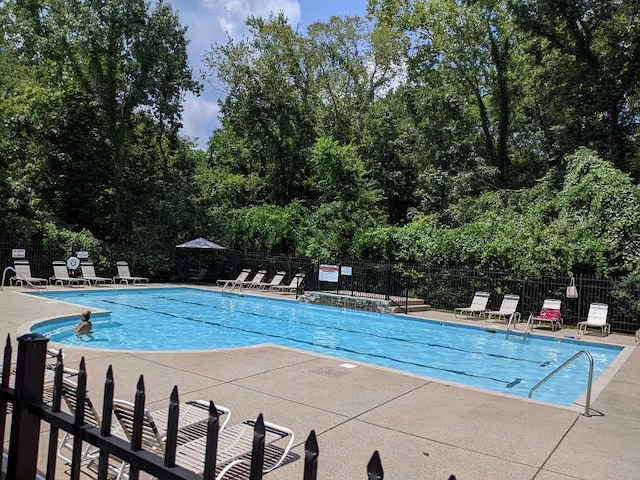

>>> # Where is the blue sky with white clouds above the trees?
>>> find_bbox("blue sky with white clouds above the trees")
[165,0,367,147]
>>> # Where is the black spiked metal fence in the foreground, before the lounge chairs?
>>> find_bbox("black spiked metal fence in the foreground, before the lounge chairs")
[0,334,455,480]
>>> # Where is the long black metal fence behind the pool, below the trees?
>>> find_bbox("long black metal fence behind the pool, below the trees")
[0,239,640,334]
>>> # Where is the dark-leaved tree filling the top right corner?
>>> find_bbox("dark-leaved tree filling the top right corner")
[510,0,640,172]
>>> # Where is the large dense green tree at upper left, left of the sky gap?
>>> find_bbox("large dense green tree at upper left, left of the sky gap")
[0,0,199,246]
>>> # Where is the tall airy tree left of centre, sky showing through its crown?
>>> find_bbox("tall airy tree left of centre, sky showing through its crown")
[205,13,317,205]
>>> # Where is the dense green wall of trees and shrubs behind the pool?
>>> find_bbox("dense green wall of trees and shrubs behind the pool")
[0,0,640,277]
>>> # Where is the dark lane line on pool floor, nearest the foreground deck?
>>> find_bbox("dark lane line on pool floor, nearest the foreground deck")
[96,300,522,388]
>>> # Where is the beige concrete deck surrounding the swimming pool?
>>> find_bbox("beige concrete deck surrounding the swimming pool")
[0,287,640,480]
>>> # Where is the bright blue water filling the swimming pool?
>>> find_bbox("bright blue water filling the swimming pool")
[32,288,622,405]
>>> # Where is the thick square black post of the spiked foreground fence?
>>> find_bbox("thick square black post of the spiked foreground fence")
[7,333,49,480]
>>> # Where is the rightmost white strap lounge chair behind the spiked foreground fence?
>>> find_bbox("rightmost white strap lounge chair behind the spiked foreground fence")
[176,414,295,480]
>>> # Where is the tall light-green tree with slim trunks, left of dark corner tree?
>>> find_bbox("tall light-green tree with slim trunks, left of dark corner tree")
[369,0,513,185]
